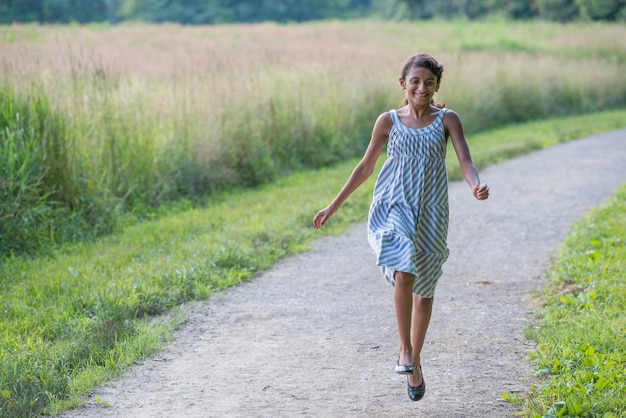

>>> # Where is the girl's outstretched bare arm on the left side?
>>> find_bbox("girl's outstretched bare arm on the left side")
[313,112,393,229]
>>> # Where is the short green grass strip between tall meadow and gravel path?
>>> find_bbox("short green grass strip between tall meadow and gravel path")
[0,111,626,416]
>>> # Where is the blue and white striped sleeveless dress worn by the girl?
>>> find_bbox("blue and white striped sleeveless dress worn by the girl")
[368,108,450,297]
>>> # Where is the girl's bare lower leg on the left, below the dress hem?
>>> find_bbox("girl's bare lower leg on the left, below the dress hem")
[393,271,417,367]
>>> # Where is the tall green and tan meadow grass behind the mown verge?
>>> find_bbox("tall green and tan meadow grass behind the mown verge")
[0,21,626,255]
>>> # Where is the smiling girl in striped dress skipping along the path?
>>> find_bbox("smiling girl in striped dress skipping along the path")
[313,54,489,401]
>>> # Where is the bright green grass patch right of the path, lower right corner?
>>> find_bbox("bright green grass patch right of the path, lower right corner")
[522,185,626,418]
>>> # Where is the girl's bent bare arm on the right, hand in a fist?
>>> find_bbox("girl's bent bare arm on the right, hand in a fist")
[443,110,489,200]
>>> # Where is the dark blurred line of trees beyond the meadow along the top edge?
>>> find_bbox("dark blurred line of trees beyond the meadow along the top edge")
[0,0,626,24]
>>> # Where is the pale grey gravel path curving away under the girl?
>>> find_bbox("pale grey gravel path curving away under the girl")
[65,130,626,418]
